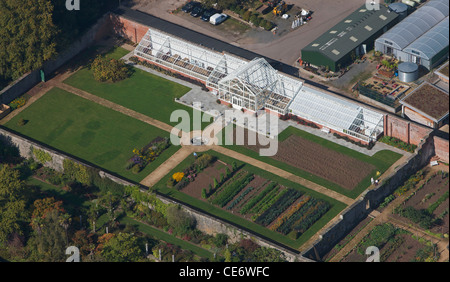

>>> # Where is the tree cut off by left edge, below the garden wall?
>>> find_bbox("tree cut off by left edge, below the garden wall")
[0,165,27,243]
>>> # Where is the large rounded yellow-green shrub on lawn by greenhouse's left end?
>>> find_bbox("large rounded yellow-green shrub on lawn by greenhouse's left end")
[91,55,131,82]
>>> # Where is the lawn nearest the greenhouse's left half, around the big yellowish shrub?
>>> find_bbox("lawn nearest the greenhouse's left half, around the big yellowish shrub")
[64,48,213,131]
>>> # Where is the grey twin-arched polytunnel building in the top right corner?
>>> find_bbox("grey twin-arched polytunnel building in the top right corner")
[375,0,449,69]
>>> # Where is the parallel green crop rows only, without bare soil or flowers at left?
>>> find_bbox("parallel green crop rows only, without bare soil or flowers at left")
[209,167,331,240]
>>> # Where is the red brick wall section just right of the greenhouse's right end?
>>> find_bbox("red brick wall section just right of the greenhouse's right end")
[384,115,432,145]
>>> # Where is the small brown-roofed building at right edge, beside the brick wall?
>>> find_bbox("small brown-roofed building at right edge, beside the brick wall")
[400,82,449,128]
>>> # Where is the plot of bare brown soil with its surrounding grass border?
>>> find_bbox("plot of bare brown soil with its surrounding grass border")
[221,127,401,199]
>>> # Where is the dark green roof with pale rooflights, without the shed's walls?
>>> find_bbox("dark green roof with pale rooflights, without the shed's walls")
[302,5,398,61]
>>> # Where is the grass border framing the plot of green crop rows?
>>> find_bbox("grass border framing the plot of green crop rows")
[154,151,346,249]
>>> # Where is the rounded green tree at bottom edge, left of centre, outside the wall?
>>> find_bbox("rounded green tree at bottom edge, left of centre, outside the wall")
[101,233,142,262]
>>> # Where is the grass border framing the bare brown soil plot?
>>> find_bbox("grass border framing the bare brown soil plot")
[219,127,402,199]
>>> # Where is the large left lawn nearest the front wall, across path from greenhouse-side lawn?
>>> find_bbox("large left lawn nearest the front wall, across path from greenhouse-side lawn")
[5,88,179,182]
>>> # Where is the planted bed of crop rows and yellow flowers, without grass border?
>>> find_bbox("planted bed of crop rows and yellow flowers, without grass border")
[168,156,331,240]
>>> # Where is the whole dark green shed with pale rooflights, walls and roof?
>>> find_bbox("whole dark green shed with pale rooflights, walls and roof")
[302,5,399,72]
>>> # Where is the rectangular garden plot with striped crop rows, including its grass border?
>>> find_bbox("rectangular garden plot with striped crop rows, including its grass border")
[154,151,345,249]
